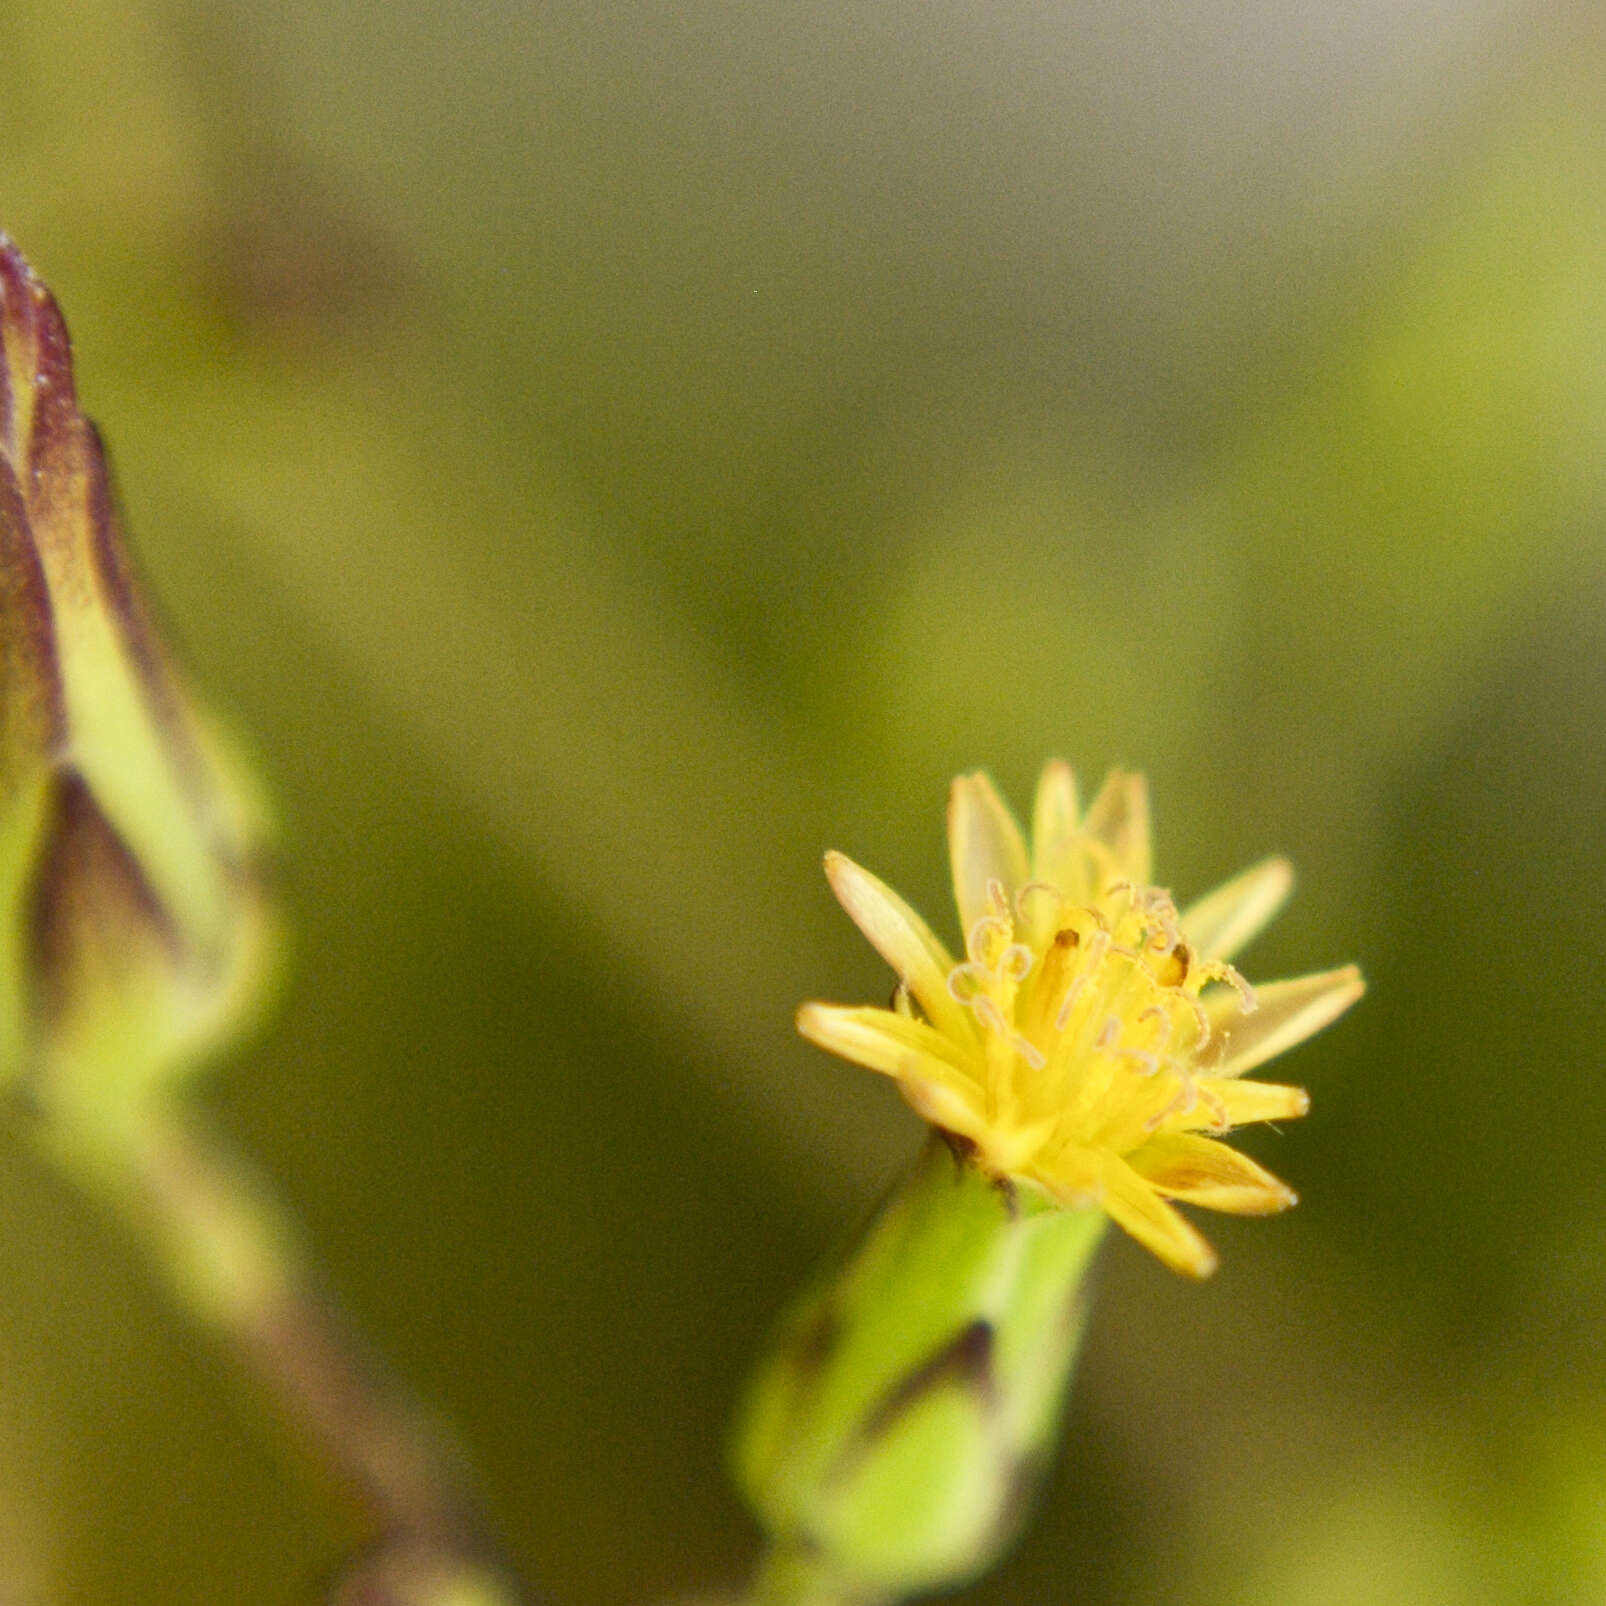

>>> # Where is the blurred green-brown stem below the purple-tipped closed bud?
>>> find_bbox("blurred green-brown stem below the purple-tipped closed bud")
[42,1107,535,1606]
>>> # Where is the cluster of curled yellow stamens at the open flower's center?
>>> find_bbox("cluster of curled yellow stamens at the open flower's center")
[948,882,1254,1153]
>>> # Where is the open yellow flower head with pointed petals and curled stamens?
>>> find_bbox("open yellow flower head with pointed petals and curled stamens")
[798,763,1363,1277]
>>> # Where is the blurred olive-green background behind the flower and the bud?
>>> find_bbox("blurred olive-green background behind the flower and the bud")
[0,0,1606,1606]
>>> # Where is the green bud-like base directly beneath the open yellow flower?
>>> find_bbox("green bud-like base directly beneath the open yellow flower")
[736,1135,1105,1601]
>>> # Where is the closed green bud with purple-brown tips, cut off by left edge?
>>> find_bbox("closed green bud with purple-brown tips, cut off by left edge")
[0,236,270,1116]
